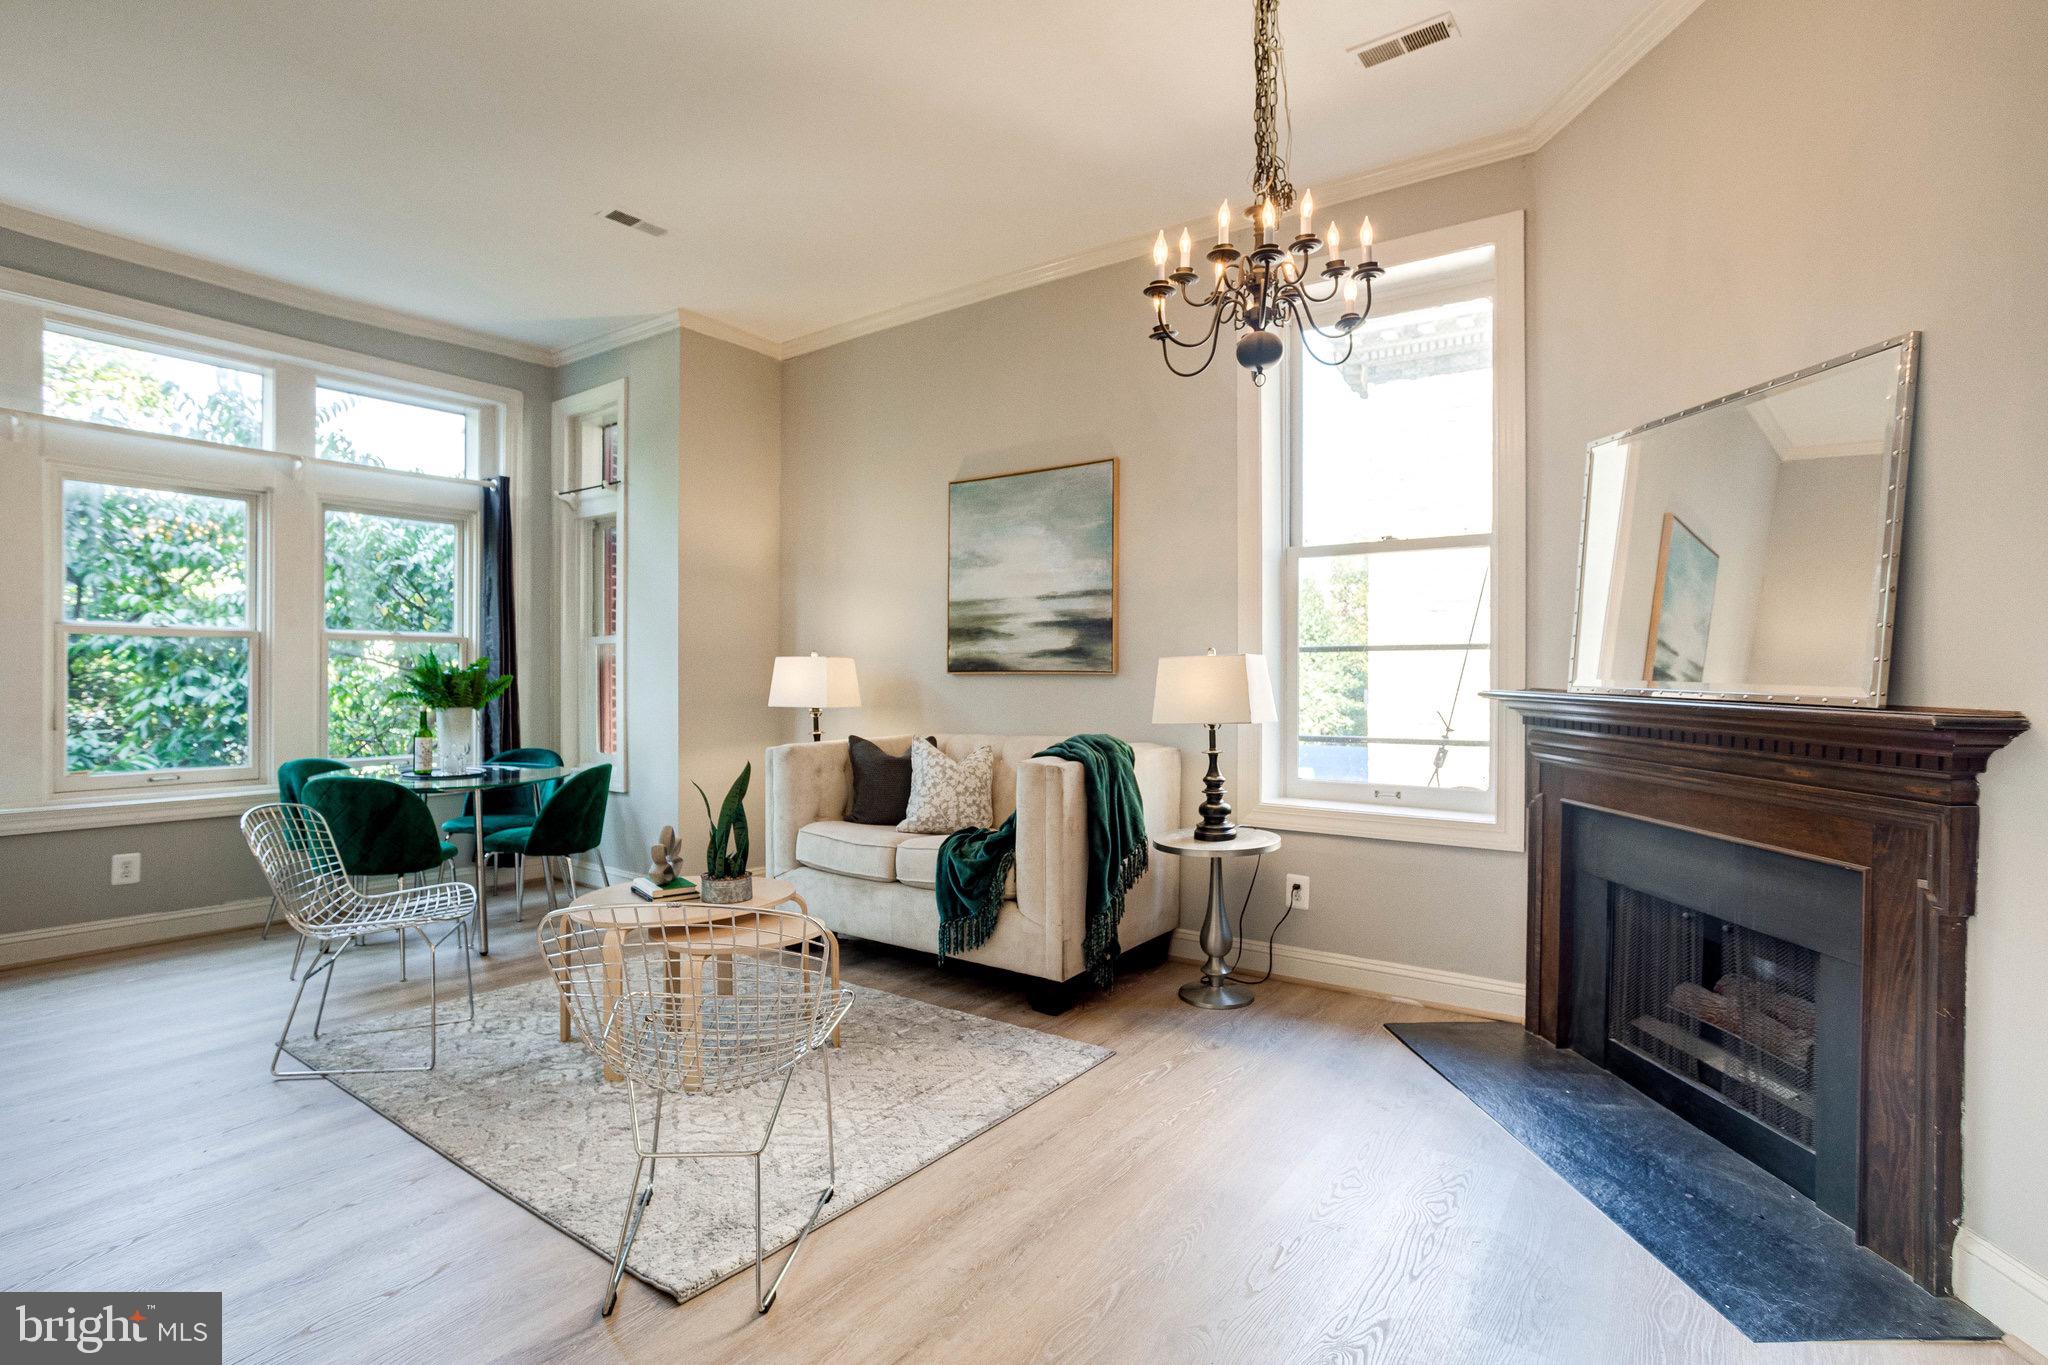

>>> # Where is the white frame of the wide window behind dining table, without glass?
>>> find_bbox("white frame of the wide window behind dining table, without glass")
[0,268,520,835]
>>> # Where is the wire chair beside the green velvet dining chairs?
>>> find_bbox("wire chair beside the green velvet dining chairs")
[242,804,477,1081]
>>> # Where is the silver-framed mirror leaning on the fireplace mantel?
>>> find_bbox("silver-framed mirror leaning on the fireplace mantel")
[1567,332,1919,706]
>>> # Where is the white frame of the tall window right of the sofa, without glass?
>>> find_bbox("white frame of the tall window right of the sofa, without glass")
[1237,213,1528,849]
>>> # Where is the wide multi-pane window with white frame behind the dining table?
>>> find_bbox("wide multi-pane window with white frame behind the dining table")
[0,272,516,833]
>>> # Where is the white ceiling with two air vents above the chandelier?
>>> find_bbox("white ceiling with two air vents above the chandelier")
[0,0,1698,360]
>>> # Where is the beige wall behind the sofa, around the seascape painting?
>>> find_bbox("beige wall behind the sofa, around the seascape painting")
[782,149,1532,980]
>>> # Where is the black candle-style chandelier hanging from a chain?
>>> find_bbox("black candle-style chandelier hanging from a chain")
[1145,0,1384,385]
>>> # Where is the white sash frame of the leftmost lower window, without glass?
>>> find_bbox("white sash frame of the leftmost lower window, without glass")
[43,465,270,794]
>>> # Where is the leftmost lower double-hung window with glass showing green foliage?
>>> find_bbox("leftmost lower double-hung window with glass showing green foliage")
[57,479,260,790]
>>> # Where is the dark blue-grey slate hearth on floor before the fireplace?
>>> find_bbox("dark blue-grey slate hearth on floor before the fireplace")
[1386,1023,1999,1342]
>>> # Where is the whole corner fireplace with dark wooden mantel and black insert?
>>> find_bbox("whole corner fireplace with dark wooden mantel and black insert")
[1491,692,2028,1293]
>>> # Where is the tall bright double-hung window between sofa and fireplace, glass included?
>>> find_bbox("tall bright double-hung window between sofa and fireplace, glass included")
[1247,219,1522,843]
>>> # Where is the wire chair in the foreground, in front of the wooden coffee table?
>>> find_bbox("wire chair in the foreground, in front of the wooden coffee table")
[539,900,852,1316]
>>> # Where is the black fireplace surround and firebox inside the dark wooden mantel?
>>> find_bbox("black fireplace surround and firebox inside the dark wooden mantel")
[1567,810,1864,1226]
